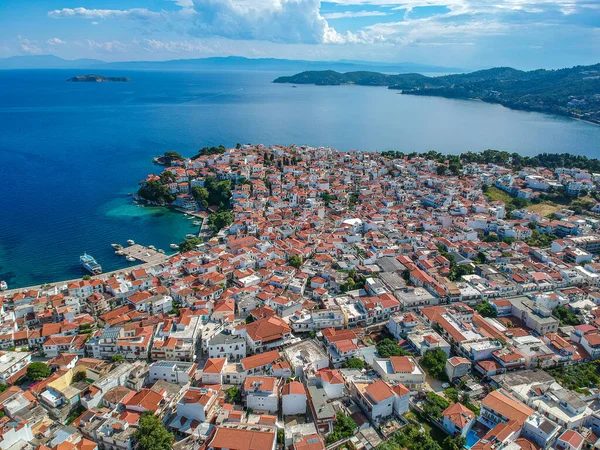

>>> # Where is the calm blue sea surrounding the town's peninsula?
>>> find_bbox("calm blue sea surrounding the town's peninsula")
[0,70,600,287]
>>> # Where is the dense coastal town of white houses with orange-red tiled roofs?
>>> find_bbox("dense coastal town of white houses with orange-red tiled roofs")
[0,144,600,450]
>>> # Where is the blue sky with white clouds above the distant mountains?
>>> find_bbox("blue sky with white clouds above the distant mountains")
[0,0,600,69]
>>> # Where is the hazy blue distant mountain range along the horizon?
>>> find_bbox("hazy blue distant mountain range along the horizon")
[0,55,460,73]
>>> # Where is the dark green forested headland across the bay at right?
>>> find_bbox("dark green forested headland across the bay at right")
[274,64,600,123]
